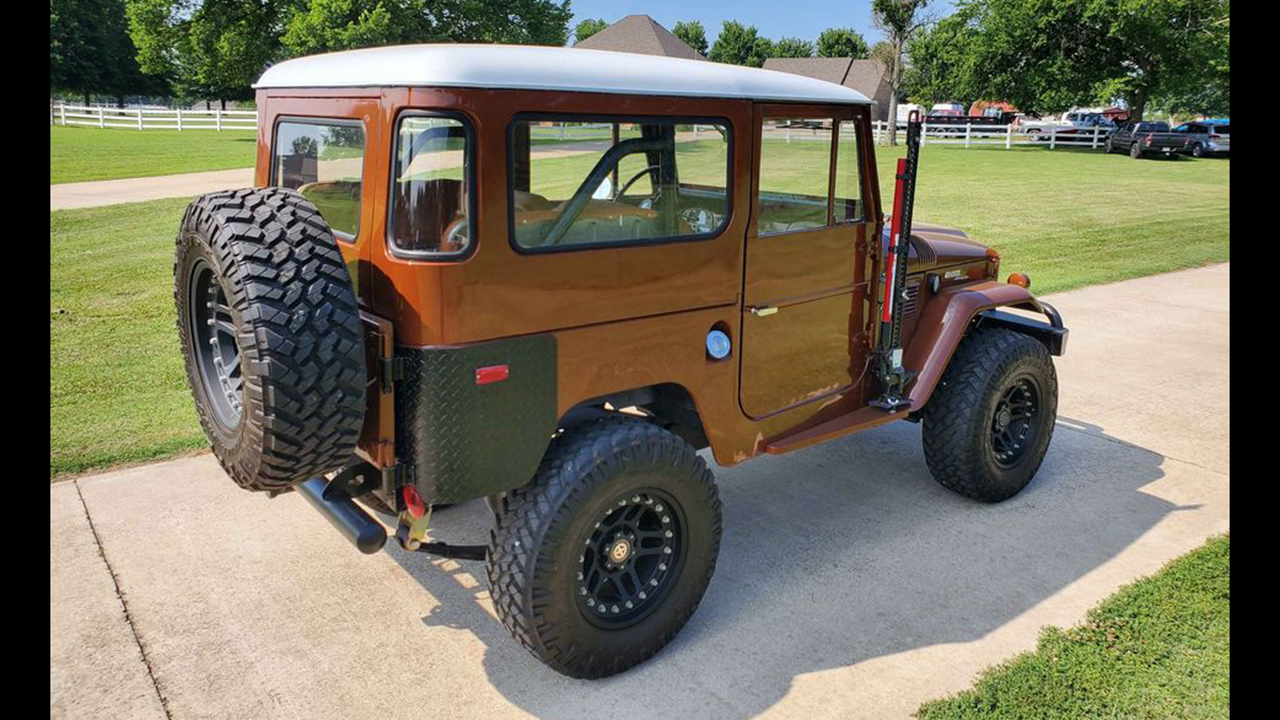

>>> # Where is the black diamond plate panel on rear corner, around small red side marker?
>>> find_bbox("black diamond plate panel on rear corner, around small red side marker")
[396,334,558,503]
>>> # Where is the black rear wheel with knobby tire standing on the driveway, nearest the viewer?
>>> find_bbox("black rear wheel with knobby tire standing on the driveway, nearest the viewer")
[488,418,721,678]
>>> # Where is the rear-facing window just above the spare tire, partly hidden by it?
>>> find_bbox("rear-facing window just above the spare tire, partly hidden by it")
[271,120,365,241]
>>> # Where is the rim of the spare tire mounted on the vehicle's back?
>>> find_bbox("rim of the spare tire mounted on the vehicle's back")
[187,260,244,430]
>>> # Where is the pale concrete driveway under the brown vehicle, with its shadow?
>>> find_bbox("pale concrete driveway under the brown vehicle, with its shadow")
[50,265,1230,719]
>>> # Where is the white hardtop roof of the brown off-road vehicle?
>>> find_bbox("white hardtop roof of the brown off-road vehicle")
[253,45,870,105]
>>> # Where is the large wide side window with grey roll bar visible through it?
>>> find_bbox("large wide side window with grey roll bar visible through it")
[509,115,730,251]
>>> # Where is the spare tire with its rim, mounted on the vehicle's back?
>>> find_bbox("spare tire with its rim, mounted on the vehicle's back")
[173,187,365,493]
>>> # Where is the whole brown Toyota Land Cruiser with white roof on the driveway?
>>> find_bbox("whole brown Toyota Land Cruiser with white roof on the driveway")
[174,45,1068,678]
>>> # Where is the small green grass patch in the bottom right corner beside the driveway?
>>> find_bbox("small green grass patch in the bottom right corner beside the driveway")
[918,537,1231,720]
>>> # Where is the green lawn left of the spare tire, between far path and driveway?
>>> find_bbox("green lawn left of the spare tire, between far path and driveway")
[49,200,206,477]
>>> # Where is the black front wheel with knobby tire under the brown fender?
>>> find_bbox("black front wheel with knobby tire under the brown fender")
[922,328,1057,502]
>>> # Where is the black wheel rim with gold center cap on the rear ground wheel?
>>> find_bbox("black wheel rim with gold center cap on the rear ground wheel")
[573,489,687,629]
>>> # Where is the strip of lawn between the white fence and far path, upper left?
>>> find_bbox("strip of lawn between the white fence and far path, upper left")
[49,126,257,184]
